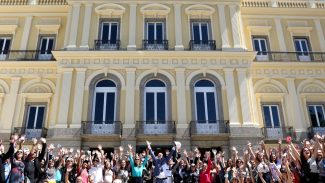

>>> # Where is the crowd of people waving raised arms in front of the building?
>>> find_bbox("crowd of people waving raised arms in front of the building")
[0,135,325,183]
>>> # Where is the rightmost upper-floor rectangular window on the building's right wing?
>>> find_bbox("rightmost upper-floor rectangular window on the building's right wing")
[294,38,311,61]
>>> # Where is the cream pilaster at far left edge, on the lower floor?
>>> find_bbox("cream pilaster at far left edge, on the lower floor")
[1,77,21,133]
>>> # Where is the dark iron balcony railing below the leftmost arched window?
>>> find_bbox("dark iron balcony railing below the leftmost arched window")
[81,121,122,136]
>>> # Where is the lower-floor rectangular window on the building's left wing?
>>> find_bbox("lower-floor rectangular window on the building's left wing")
[26,105,46,129]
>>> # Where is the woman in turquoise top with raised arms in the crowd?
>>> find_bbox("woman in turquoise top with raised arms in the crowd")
[128,144,148,183]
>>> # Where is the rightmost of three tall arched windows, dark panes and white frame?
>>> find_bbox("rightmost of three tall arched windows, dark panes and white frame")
[194,79,218,123]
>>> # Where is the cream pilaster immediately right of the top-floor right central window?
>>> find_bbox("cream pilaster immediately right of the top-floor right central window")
[218,4,230,50]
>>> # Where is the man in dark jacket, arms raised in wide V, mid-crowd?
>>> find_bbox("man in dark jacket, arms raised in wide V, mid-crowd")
[147,141,180,183]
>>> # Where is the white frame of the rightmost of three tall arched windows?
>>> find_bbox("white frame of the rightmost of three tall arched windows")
[194,83,219,123]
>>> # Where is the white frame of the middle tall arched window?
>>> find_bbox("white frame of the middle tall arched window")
[143,80,168,121]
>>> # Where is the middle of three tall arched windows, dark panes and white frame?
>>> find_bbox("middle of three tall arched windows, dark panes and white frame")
[144,79,167,123]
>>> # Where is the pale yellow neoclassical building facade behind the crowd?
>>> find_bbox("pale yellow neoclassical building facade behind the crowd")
[0,0,325,151]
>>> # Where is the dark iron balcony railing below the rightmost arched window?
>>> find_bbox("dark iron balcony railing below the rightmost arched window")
[190,120,229,135]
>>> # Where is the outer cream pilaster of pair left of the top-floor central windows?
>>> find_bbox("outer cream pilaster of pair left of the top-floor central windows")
[67,3,81,50]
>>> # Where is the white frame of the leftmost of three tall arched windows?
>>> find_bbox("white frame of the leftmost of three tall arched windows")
[92,80,117,124]
